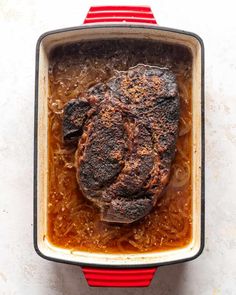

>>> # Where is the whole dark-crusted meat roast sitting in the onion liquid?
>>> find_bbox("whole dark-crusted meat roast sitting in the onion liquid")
[63,64,180,223]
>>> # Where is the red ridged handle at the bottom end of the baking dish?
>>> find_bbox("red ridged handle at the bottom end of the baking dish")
[82,267,157,287]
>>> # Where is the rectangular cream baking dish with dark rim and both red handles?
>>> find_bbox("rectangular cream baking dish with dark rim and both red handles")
[34,6,204,287]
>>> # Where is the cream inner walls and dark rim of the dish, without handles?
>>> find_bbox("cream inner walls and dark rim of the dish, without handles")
[36,25,203,266]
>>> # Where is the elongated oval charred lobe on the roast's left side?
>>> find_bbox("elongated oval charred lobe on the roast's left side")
[76,103,125,198]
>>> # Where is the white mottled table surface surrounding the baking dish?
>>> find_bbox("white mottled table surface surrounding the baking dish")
[0,0,236,295]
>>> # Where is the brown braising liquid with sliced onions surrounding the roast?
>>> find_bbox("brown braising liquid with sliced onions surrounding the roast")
[47,40,192,253]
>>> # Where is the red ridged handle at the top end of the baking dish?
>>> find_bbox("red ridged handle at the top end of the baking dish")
[84,6,157,25]
